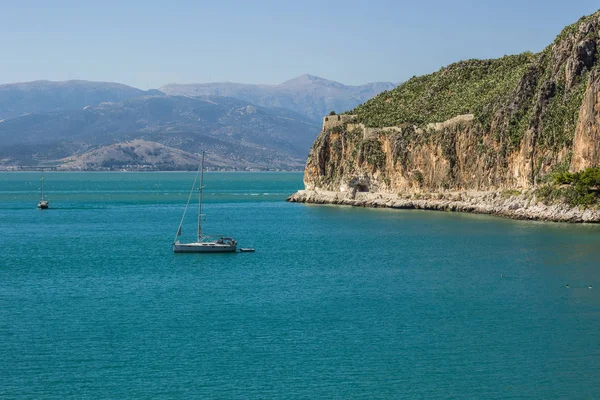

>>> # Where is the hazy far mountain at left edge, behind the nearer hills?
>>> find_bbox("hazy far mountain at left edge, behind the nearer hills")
[0,81,162,119]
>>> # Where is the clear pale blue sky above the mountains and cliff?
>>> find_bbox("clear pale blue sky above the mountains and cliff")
[0,0,600,89]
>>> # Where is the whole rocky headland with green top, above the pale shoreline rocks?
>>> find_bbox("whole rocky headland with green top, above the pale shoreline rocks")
[304,12,600,198]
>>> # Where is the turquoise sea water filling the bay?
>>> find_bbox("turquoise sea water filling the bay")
[0,173,600,399]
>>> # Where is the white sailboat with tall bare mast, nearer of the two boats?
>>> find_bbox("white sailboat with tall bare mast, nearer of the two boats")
[173,152,237,253]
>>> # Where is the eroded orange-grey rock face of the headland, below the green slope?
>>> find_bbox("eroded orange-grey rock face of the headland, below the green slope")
[304,13,600,196]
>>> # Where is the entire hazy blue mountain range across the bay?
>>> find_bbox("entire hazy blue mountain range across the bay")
[0,75,394,169]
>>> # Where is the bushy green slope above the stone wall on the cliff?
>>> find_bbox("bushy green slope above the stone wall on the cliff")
[352,53,535,127]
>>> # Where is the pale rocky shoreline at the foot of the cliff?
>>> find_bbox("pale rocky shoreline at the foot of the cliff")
[287,190,600,223]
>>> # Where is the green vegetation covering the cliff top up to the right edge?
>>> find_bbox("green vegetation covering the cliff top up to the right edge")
[349,11,600,154]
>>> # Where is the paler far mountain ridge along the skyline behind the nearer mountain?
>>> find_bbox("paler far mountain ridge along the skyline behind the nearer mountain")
[0,74,396,122]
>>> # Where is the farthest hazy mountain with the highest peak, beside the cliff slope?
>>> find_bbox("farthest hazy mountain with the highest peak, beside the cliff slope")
[159,75,396,121]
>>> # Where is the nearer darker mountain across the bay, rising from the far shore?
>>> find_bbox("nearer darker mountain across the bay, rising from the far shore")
[0,95,320,169]
